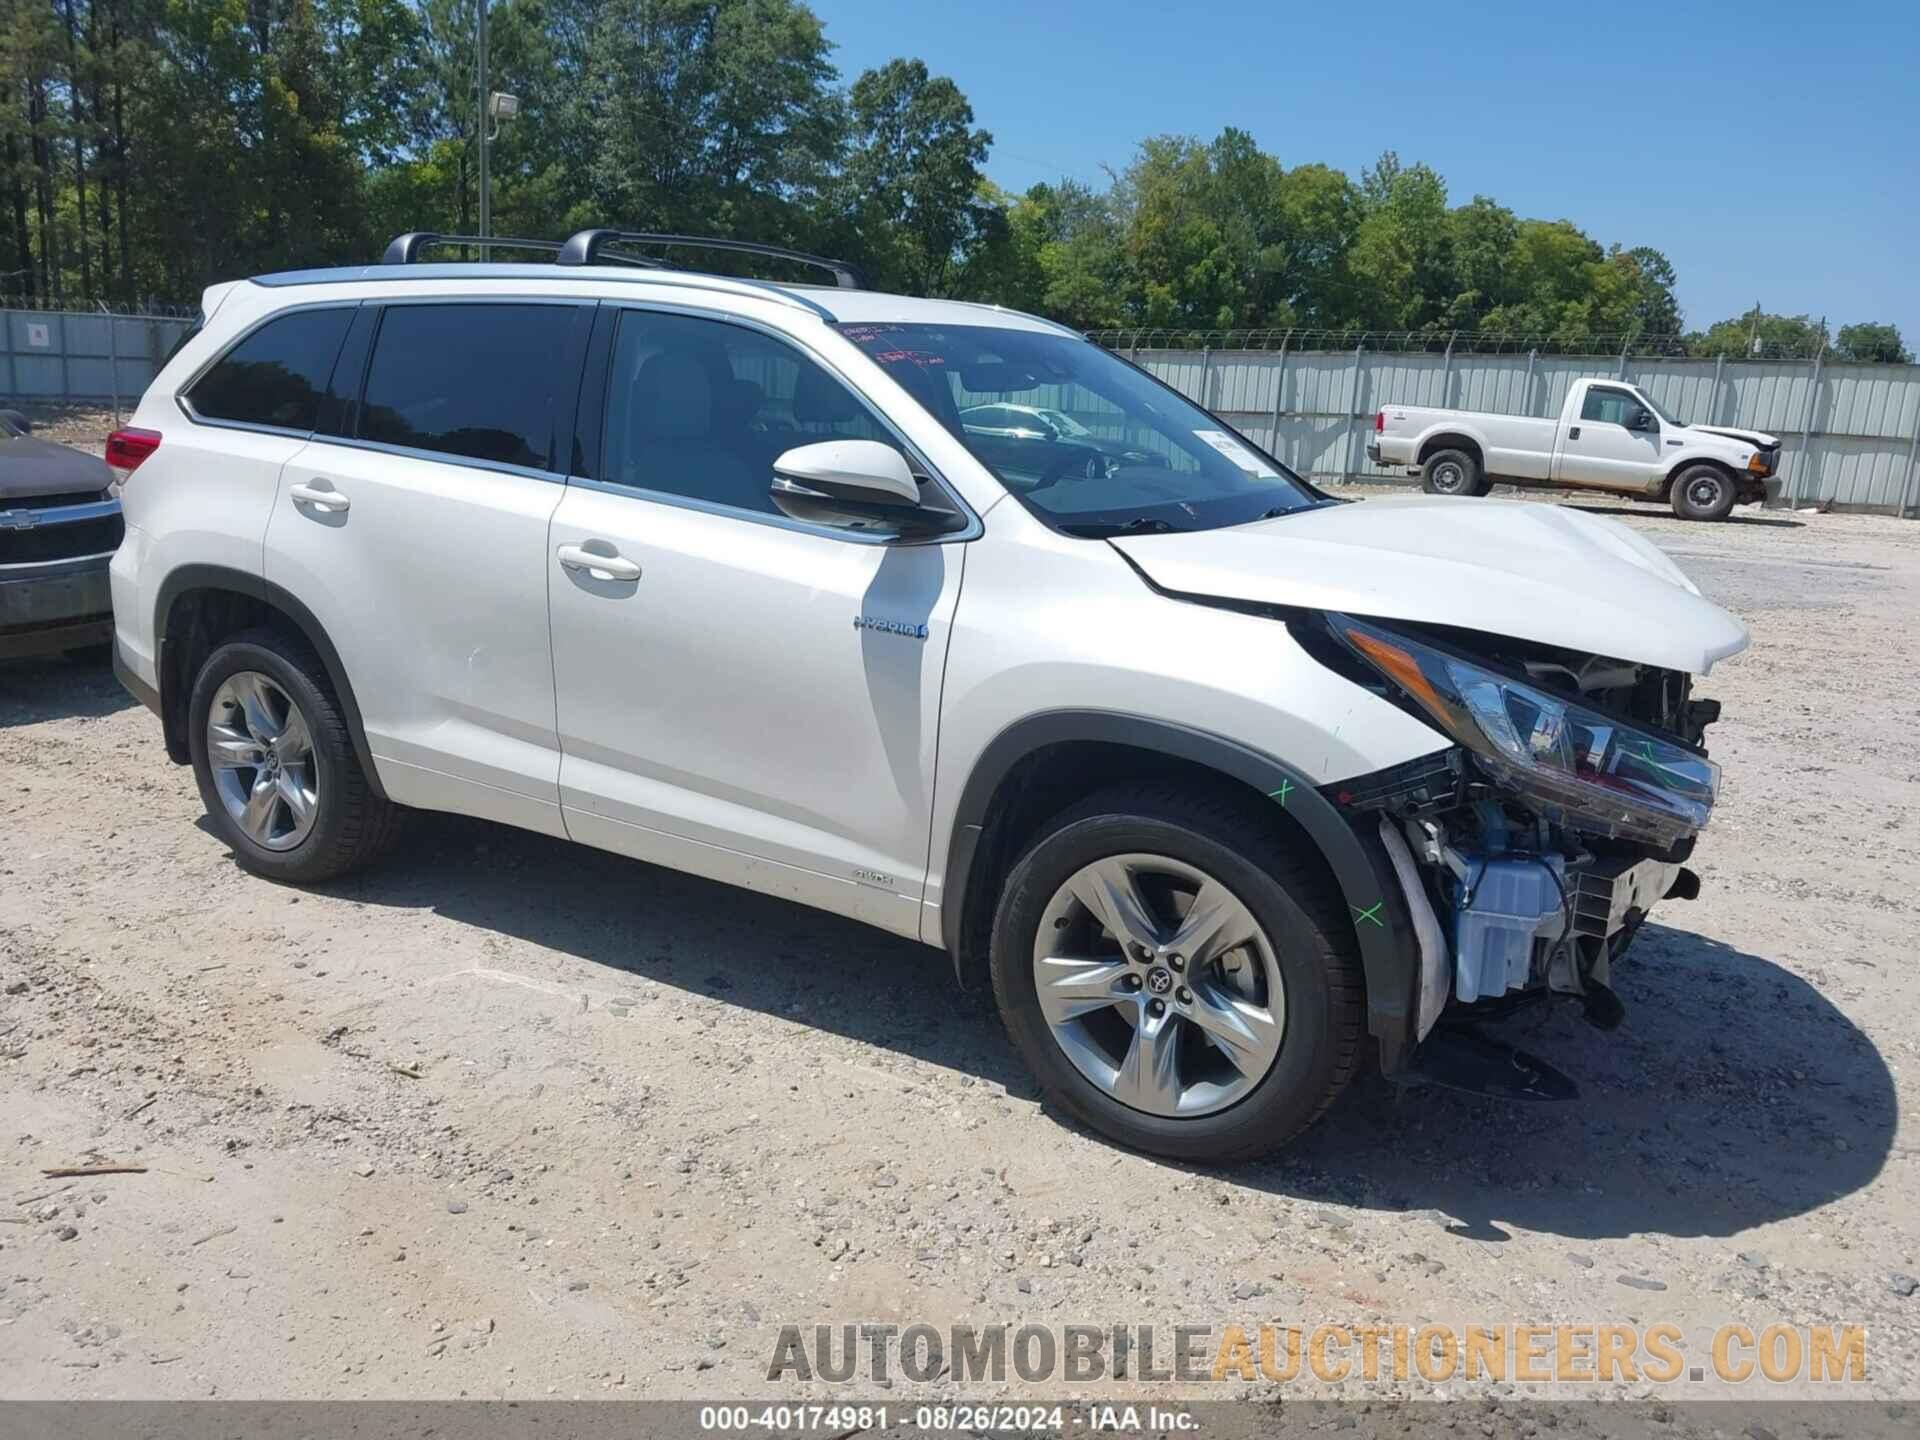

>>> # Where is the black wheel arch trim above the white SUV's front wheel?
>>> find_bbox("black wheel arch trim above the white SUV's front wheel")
[941,710,1419,1073]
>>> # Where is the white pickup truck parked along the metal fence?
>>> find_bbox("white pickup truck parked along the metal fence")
[1367,380,1780,520]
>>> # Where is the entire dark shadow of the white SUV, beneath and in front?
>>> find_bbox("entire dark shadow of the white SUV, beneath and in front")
[336,816,1895,1240]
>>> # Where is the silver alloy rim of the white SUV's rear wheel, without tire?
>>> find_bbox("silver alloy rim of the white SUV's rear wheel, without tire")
[207,670,321,851]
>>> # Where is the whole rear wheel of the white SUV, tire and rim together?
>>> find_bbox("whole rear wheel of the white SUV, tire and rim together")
[186,630,401,885]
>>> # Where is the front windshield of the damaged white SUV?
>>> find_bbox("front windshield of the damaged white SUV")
[841,324,1323,536]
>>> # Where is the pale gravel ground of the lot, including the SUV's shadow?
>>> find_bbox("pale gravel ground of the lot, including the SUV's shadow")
[0,503,1920,1432]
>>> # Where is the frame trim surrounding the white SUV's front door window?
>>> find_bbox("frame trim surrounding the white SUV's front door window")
[566,300,985,545]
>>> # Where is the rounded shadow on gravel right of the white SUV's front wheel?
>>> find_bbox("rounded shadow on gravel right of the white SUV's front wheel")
[1259,906,1897,1240]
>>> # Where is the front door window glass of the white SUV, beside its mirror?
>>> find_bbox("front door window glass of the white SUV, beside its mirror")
[601,309,899,515]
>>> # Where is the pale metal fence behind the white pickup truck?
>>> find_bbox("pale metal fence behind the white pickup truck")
[1131,349,1920,515]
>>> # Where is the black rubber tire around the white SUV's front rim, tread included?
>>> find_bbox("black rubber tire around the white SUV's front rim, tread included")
[991,781,1367,1164]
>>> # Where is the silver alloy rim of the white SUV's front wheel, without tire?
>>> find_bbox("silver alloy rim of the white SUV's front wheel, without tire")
[1033,854,1286,1117]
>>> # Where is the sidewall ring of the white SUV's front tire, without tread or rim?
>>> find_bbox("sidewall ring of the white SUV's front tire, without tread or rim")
[993,816,1336,1160]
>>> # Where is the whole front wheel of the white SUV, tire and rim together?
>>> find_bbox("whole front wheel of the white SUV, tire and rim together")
[991,783,1365,1162]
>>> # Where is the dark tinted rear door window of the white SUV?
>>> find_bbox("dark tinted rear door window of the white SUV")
[359,305,578,470]
